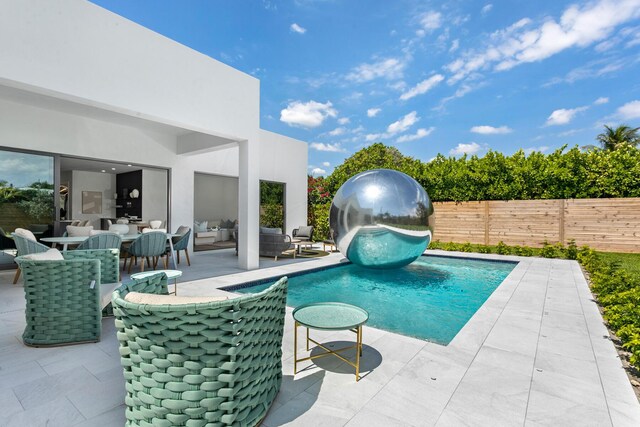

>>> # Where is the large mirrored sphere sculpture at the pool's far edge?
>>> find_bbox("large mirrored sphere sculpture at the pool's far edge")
[329,169,434,268]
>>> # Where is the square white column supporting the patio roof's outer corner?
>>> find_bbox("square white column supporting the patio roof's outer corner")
[238,138,260,270]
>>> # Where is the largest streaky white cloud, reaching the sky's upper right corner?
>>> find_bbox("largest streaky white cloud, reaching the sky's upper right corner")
[446,0,640,83]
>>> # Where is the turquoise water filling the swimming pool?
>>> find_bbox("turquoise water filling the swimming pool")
[235,256,517,345]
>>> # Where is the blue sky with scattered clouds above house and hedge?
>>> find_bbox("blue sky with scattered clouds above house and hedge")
[93,0,640,175]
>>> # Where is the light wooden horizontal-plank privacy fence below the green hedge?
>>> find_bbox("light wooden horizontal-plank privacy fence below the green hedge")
[433,198,640,253]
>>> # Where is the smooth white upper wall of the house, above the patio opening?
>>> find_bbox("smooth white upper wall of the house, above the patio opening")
[0,0,260,139]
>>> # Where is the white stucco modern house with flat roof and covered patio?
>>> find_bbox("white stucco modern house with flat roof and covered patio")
[0,0,307,269]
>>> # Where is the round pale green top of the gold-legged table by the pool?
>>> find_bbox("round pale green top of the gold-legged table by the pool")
[293,302,369,331]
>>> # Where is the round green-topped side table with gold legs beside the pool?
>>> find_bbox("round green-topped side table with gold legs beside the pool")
[293,302,369,381]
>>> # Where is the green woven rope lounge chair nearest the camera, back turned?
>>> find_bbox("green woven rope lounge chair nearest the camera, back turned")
[112,273,287,426]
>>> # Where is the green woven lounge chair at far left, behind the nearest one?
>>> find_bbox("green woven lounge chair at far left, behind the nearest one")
[16,249,120,346]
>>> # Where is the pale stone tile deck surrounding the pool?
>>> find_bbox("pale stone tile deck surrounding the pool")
[0,251,640,427]
